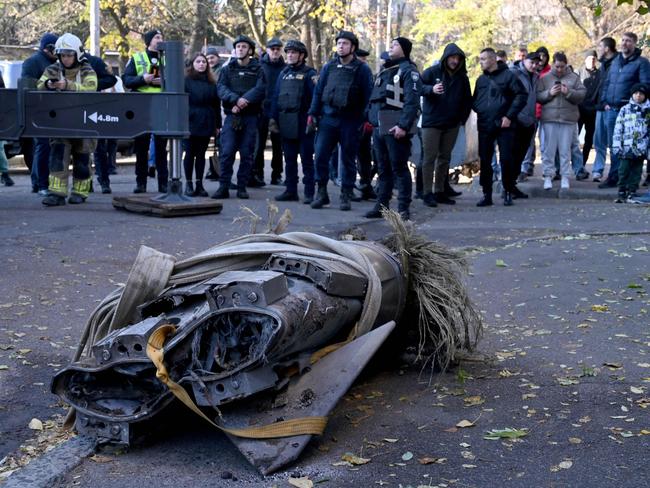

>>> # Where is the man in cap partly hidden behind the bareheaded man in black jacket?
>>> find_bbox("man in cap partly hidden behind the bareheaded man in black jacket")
[512,51,542,194]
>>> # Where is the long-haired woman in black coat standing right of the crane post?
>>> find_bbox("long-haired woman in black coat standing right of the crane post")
[183,53,221,197]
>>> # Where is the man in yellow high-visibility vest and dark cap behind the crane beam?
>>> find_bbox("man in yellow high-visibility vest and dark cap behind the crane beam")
[122,30,169,193]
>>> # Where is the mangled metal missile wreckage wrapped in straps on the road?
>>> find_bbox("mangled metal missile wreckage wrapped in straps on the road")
[52,213,481,474]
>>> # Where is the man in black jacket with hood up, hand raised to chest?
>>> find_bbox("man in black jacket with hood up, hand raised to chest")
[422,42,472,207]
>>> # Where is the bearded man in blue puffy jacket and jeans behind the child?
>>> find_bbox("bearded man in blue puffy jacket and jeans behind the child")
[598,32,650,188]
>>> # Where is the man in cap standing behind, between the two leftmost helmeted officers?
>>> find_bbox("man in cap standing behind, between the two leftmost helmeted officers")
[248,37,285,187]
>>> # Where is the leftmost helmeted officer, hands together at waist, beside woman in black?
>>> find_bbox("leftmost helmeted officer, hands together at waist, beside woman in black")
[212,35,266,199]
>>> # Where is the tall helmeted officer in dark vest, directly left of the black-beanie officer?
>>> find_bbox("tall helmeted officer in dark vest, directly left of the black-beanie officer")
[307,31,372,210]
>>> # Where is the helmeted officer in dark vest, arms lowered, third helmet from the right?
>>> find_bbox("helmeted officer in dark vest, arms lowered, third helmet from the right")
[269,40,318,203]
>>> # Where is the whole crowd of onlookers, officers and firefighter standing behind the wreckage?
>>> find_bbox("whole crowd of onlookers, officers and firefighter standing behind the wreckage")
[0,30,650,215]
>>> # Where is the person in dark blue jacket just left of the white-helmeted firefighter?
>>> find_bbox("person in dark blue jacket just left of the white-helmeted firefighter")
[20,32,59,196]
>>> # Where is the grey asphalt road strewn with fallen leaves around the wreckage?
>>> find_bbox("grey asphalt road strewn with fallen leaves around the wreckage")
[0,168,650,488]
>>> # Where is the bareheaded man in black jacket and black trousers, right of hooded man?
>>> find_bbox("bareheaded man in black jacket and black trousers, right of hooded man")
[473,47,527,207]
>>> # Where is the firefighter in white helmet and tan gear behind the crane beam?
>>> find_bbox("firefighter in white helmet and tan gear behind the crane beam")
[37,33,97,207]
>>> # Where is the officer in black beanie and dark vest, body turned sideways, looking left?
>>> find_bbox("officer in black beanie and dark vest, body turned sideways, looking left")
[366,37,422,220]
